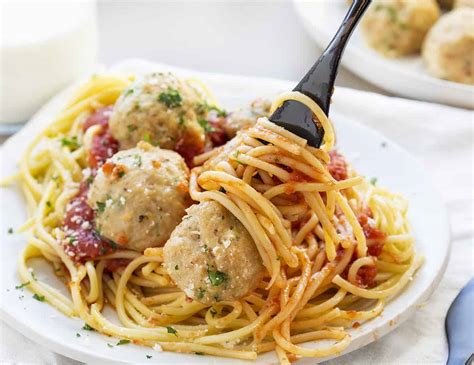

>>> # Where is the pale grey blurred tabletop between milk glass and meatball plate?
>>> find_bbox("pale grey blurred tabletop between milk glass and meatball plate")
[93,0,371,89]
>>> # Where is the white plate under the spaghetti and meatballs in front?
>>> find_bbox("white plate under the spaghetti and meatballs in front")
[0,61,449,364]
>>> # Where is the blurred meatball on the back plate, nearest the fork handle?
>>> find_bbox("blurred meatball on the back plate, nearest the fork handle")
[361,0,440,57]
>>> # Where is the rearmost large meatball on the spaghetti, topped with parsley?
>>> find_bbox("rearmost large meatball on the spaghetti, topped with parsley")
[109,73,205,150]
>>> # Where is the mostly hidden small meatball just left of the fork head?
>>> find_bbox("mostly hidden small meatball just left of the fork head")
[224,98,272,139]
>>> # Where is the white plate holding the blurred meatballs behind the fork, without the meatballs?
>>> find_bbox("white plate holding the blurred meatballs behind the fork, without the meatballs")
[294,0,474,108]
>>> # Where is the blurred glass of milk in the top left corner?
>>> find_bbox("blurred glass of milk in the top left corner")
[0,0,98,125]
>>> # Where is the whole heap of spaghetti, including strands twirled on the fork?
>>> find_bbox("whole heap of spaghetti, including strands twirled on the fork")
[7,76,422,364]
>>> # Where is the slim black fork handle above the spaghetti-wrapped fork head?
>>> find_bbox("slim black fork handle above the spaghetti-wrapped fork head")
[293,0,371,115]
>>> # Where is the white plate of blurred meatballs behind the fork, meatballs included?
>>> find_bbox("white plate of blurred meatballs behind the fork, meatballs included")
[294,0,474,108]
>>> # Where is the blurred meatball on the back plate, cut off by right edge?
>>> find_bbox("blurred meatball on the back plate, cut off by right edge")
[423,8,474,85]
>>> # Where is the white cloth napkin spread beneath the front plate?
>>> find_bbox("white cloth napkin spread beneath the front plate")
[0,80,474,365]
